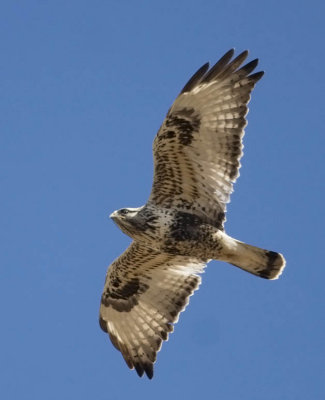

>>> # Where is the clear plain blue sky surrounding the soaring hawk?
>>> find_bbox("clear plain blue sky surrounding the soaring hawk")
[0,0,325,400]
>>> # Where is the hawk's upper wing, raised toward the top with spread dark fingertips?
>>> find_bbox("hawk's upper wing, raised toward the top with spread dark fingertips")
[149,50,263,228]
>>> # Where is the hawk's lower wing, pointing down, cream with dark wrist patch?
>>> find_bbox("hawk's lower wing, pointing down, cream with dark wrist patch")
[99,242,205,378]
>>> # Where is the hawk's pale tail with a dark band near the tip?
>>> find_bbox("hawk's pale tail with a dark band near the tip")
[219,235,286,279]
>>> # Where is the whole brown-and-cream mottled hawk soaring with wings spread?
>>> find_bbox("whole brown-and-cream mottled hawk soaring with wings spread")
[99,50,285,379]
